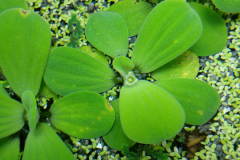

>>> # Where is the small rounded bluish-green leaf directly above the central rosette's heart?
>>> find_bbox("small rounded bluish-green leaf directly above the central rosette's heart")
[86,12,128,58]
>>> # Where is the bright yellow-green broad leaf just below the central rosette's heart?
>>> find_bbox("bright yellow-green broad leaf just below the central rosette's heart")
[120,80,185,144]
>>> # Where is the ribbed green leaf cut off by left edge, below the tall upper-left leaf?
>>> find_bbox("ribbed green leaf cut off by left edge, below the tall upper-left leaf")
[0,94,25,139]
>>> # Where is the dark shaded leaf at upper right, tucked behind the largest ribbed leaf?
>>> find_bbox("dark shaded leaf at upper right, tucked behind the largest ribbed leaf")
[189,2,228,56]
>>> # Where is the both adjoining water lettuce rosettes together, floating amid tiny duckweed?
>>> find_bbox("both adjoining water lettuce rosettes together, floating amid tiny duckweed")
[0,0,232,160]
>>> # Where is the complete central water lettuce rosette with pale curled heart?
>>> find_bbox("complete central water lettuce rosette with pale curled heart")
[44,0,223,150]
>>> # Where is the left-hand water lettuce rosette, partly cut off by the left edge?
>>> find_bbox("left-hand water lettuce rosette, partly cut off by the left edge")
[0,8,115,160]
